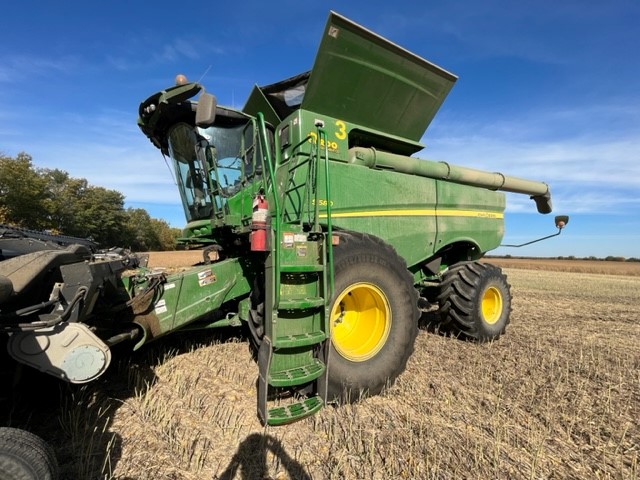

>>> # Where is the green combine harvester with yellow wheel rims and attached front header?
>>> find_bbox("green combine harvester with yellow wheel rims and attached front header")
[0,13,568,480]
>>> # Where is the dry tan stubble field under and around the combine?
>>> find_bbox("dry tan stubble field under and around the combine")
[2,252,640,479]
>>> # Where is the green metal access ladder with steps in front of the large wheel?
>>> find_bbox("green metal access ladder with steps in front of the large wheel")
[258,115,333,425]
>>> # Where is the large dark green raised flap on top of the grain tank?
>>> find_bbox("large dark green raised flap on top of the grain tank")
[302,12,457,141]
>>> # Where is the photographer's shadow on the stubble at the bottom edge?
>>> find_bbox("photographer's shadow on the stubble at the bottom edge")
[213,433,311,480]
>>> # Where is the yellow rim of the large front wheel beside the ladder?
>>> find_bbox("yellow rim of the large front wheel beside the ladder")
[331,283,391,362]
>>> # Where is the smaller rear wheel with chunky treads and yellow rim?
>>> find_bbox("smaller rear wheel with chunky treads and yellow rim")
[438,262,511,342]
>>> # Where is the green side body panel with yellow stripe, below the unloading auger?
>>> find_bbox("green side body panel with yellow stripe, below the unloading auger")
[312,162,505,268]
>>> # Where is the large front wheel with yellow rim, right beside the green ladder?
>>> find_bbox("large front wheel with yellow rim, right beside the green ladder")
[328,233,419,402]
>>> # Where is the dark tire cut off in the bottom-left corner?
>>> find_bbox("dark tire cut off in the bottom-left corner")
[0,427,58,480]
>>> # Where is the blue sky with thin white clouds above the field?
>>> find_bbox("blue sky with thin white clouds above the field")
[0,0,640,257]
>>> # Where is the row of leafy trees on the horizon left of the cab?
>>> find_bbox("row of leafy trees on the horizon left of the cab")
[0,153,180,251]
